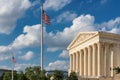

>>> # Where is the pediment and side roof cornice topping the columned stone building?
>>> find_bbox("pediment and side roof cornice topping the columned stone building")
[67,31,120,50]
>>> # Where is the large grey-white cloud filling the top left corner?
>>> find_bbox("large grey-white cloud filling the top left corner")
[0,0,31,34]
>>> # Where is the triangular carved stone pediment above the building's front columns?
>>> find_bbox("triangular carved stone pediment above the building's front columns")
[67,32,98,50]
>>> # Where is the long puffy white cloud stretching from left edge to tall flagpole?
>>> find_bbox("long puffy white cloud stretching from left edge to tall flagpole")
[0,25,40,53]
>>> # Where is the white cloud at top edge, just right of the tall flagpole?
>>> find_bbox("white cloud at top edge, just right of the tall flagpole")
[44,0,72,11]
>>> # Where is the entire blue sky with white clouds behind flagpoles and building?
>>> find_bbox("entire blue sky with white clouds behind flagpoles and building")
[0,0,120,70]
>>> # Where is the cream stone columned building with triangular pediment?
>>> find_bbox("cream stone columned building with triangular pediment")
[67,32,120,80]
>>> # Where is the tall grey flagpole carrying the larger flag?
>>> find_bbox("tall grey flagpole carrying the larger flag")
[41,0,43,71]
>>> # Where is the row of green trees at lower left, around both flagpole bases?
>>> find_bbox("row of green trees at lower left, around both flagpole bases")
[3,66,50,80]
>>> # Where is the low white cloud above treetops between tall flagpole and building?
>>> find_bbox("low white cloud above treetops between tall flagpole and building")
[45,60,69,71]
